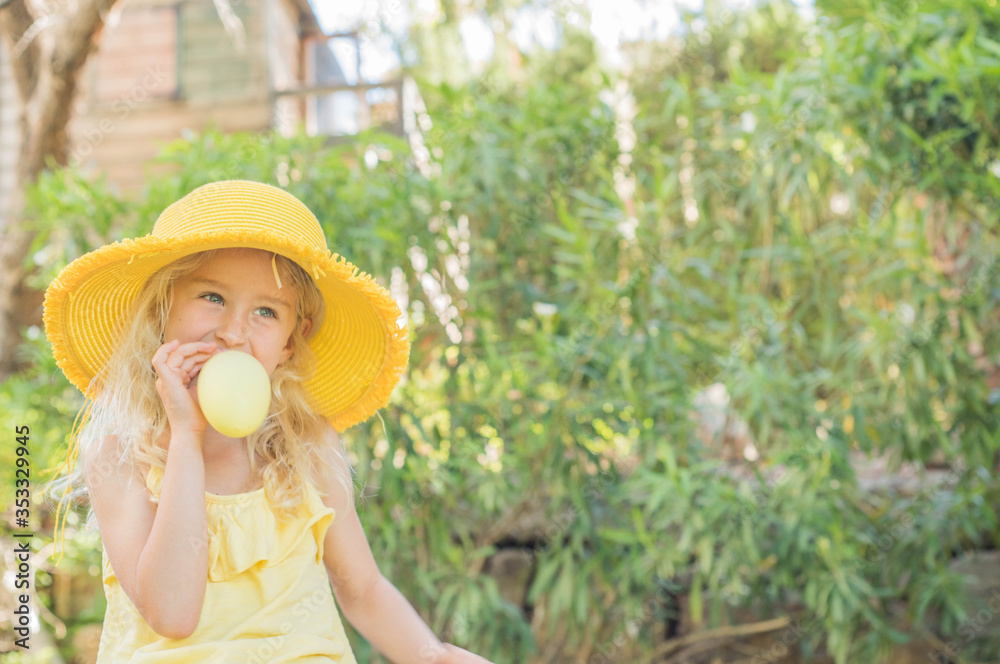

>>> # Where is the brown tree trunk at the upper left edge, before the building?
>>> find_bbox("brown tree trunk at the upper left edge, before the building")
[0,0,116,380]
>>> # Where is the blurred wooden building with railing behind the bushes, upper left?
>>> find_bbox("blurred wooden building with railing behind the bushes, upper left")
[0,0,416,202]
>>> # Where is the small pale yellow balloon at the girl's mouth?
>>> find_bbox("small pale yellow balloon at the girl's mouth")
[198,350,271,438]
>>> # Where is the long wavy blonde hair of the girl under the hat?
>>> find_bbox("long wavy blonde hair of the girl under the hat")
[49,250,352,527]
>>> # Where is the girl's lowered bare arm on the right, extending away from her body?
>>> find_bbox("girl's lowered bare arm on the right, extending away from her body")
[321,428,489,664]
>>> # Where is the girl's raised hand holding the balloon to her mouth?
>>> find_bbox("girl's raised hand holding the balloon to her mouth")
[153,339,219,435]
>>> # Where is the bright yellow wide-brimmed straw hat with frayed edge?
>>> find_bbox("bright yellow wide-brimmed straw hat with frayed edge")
[44,180,410,431]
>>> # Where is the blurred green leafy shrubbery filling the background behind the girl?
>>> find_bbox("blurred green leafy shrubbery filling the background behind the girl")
[0,0,1000,664]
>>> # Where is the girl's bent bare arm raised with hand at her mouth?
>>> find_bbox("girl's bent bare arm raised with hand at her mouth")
[84,342,214,639]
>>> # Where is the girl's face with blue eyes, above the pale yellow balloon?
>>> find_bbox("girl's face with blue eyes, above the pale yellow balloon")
[164,249,308,378]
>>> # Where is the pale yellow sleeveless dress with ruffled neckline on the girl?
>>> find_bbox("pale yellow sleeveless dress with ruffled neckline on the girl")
[97,467,357,664]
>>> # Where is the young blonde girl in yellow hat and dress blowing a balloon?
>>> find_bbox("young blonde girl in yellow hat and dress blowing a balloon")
[45,181,494,664]
